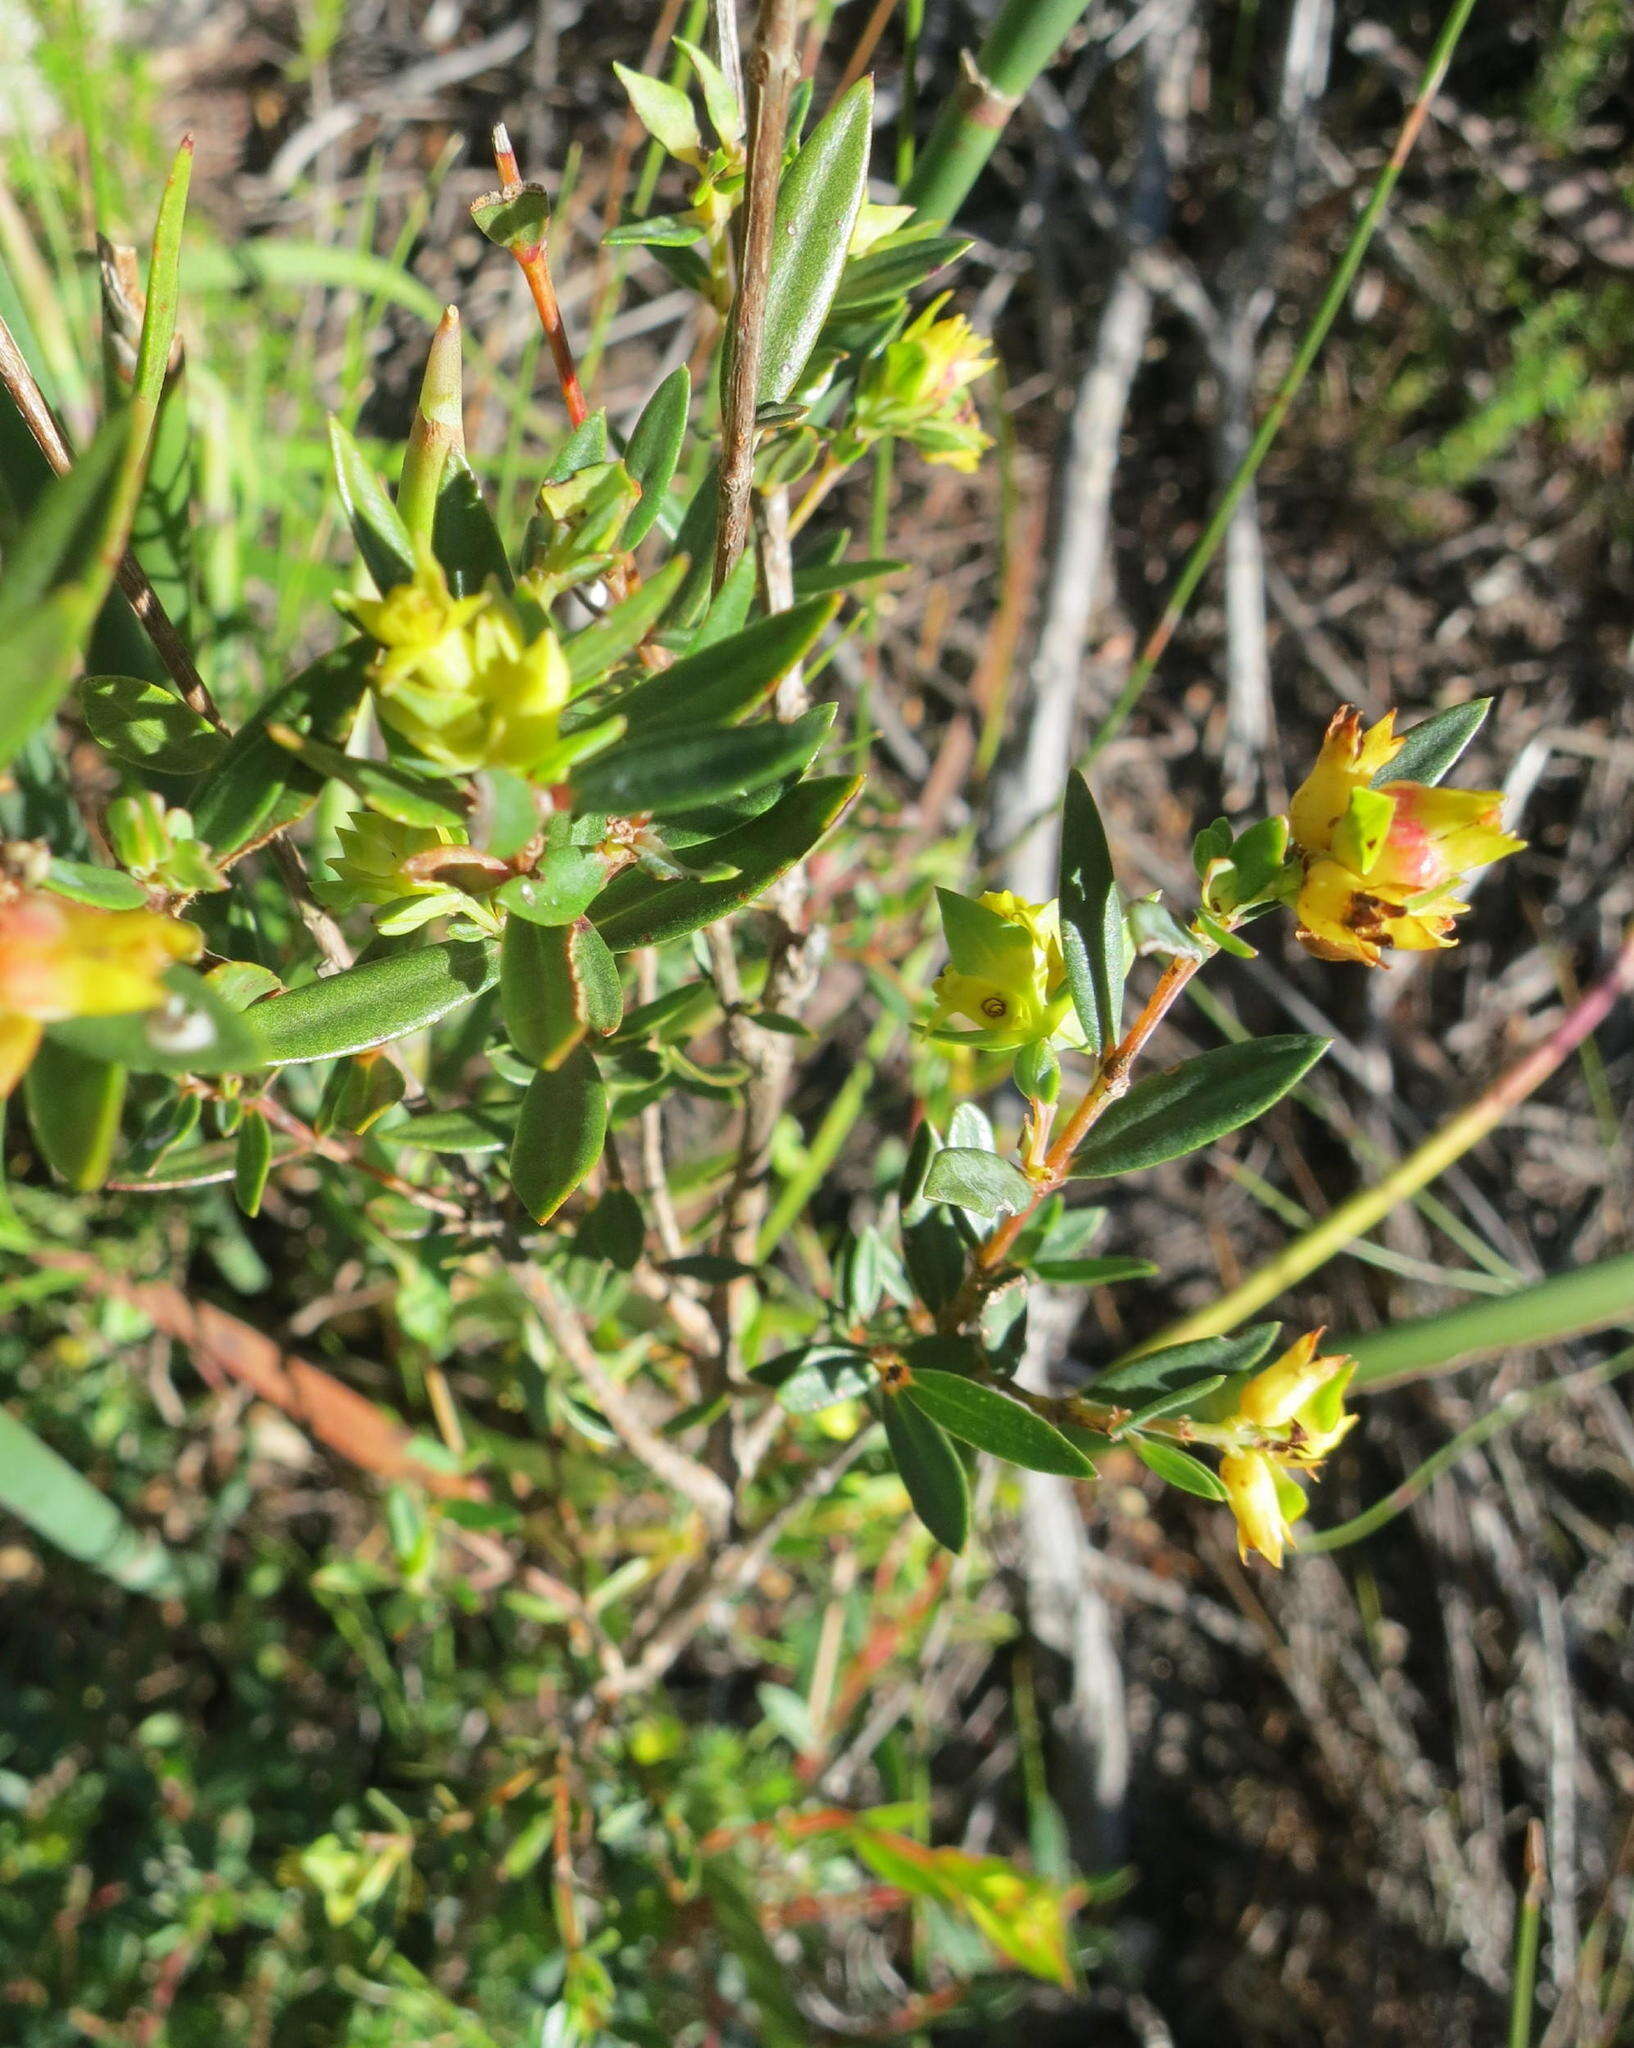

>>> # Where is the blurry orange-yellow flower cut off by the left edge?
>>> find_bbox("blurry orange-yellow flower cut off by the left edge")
[0,891,201,1098]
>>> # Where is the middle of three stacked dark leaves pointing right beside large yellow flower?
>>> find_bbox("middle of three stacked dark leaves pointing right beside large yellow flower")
[573,705,837,817]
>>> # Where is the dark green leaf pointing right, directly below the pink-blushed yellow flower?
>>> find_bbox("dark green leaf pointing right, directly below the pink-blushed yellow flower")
[1073,1032,1329,1180]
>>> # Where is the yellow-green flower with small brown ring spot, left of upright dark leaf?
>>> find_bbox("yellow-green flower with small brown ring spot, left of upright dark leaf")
[928,889,1081,1053]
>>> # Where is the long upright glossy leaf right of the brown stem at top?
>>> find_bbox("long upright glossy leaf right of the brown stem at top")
[756,78,874,406]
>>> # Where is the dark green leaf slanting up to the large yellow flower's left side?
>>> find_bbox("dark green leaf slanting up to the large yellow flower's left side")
[192,639,373,860]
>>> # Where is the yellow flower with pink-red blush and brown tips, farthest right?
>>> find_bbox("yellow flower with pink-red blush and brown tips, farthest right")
[1288,705,1525,967]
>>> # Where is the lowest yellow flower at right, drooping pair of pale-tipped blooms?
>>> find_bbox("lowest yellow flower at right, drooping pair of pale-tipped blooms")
[1220,1329,1356,1567]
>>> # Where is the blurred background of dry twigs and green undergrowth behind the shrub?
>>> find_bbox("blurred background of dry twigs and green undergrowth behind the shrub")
[0,0,1634,2048]
